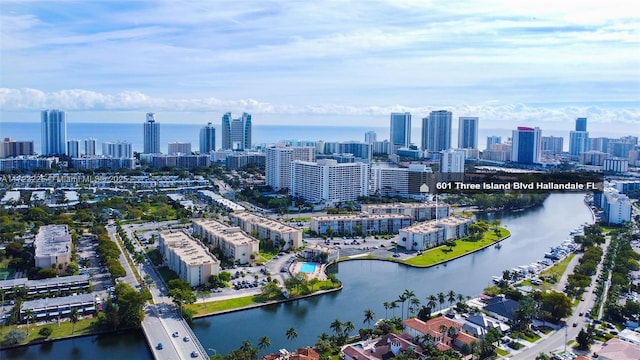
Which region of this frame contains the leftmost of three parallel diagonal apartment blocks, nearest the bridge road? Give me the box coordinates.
[158,230,220,286]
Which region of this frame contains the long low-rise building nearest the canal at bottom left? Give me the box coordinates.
[20,294,96,323]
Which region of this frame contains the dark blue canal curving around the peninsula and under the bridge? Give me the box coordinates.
[0,194,593,359]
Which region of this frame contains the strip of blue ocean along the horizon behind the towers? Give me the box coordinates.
[0,121,629,154]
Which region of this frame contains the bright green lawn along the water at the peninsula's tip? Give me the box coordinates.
[403,227,510,267]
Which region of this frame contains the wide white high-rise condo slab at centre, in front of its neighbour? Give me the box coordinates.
[289,159,369,203]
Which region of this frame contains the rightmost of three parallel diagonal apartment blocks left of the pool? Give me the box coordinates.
[229,211,302,250]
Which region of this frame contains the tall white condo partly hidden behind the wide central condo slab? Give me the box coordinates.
[265,146,316,191]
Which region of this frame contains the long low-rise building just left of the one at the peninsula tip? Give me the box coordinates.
[309,213,411,235]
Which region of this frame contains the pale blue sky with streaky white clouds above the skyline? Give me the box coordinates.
[0,0,640,133]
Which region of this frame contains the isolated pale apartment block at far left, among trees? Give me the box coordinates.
[33,225,71,269]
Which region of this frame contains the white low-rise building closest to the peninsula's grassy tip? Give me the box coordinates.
[398,216,473,251]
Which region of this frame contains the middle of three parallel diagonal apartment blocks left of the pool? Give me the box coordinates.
[193,219,260,264]
